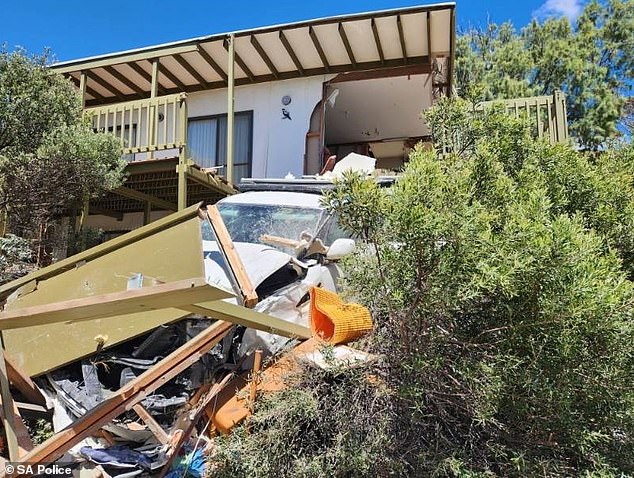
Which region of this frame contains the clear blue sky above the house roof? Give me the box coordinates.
[0,0,584,61]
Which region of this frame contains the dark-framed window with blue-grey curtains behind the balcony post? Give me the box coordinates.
[187,111,253,182]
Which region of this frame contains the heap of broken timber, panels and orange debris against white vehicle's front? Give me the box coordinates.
[0,200,372,478]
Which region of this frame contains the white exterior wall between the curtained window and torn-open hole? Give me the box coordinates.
[187,75,334,178]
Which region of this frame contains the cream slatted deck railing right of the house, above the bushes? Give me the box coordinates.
[476,90,568,143]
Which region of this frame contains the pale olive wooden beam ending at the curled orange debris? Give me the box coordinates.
[179,300,311,339]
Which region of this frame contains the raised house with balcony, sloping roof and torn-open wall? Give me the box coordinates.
[52,3,455,230]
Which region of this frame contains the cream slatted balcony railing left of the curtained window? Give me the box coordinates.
[84,93,187,155]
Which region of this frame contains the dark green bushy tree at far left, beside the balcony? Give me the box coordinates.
[0,47,124,266]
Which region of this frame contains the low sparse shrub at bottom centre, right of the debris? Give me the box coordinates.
[208,362,396,478]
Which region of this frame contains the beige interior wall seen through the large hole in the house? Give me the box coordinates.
[325,74,432,145]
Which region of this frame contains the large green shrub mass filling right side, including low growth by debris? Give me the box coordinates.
[212,99,634,477]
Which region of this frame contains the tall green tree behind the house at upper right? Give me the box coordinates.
[456,0,634,149]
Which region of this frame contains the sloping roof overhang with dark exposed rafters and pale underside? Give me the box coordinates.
[52,3,455,104]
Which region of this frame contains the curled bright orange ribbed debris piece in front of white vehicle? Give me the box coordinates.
[310,287,372,344]
